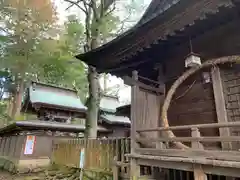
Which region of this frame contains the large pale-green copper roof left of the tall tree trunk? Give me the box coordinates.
[23,82,87,112]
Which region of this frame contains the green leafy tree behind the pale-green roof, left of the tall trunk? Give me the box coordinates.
[39,15,88,100]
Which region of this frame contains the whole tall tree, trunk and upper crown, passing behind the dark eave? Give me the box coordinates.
[62,0,146,138]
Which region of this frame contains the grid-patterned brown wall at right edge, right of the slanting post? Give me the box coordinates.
[221,65,240,149]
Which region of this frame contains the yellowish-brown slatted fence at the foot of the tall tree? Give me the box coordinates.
[52,138,130,173]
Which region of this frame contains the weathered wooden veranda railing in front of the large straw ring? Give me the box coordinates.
[136,122,240,165]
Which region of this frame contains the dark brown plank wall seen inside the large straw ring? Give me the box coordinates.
[167,73,220,149]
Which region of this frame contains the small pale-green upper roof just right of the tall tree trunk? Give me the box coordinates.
[100,95,120,113]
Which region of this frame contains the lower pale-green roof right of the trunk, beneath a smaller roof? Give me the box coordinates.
[100,114,131,125]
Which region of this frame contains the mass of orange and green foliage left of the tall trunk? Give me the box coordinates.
[0,0,87,102]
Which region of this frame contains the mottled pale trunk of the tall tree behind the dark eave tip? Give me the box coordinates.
[76,0,115,138]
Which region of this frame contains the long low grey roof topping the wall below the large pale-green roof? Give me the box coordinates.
[0,121,109,135]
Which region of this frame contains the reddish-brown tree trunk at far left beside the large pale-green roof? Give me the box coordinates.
[11,79,24,120]
